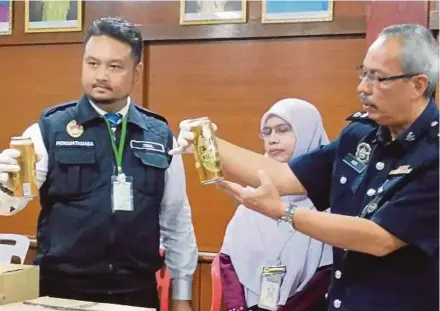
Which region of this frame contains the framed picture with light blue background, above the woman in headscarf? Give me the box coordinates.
[261,0,333,23]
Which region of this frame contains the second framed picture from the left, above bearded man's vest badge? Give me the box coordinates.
[25,0,82,33]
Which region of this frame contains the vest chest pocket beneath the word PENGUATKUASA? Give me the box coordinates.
[52,148,101,196]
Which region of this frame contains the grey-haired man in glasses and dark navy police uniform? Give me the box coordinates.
[171,25,439,311]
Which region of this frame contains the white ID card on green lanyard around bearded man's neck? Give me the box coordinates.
[104,116,133,213]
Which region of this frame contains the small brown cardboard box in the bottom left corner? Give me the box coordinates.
[0,264,40,305]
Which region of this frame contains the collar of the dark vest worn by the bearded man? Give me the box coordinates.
[76,95,148,130]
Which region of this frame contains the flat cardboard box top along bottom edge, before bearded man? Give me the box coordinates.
[0,297,155,311]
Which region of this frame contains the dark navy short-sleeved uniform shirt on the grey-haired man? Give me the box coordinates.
[289,100,439,311]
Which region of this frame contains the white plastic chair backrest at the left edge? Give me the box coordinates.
[0,233,30,264]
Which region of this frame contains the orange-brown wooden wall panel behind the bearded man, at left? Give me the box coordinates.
[0,44,143,236]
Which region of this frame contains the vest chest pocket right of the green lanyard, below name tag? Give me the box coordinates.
[133,149,169,194]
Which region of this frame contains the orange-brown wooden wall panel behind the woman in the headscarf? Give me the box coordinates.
[145,38,365,252]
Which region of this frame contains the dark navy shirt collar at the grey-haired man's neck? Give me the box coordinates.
[376,99,439,149]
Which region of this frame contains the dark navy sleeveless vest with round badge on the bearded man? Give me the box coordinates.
[36,97,173,292]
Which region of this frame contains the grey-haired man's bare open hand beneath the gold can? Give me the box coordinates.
[217,171,285,219]
